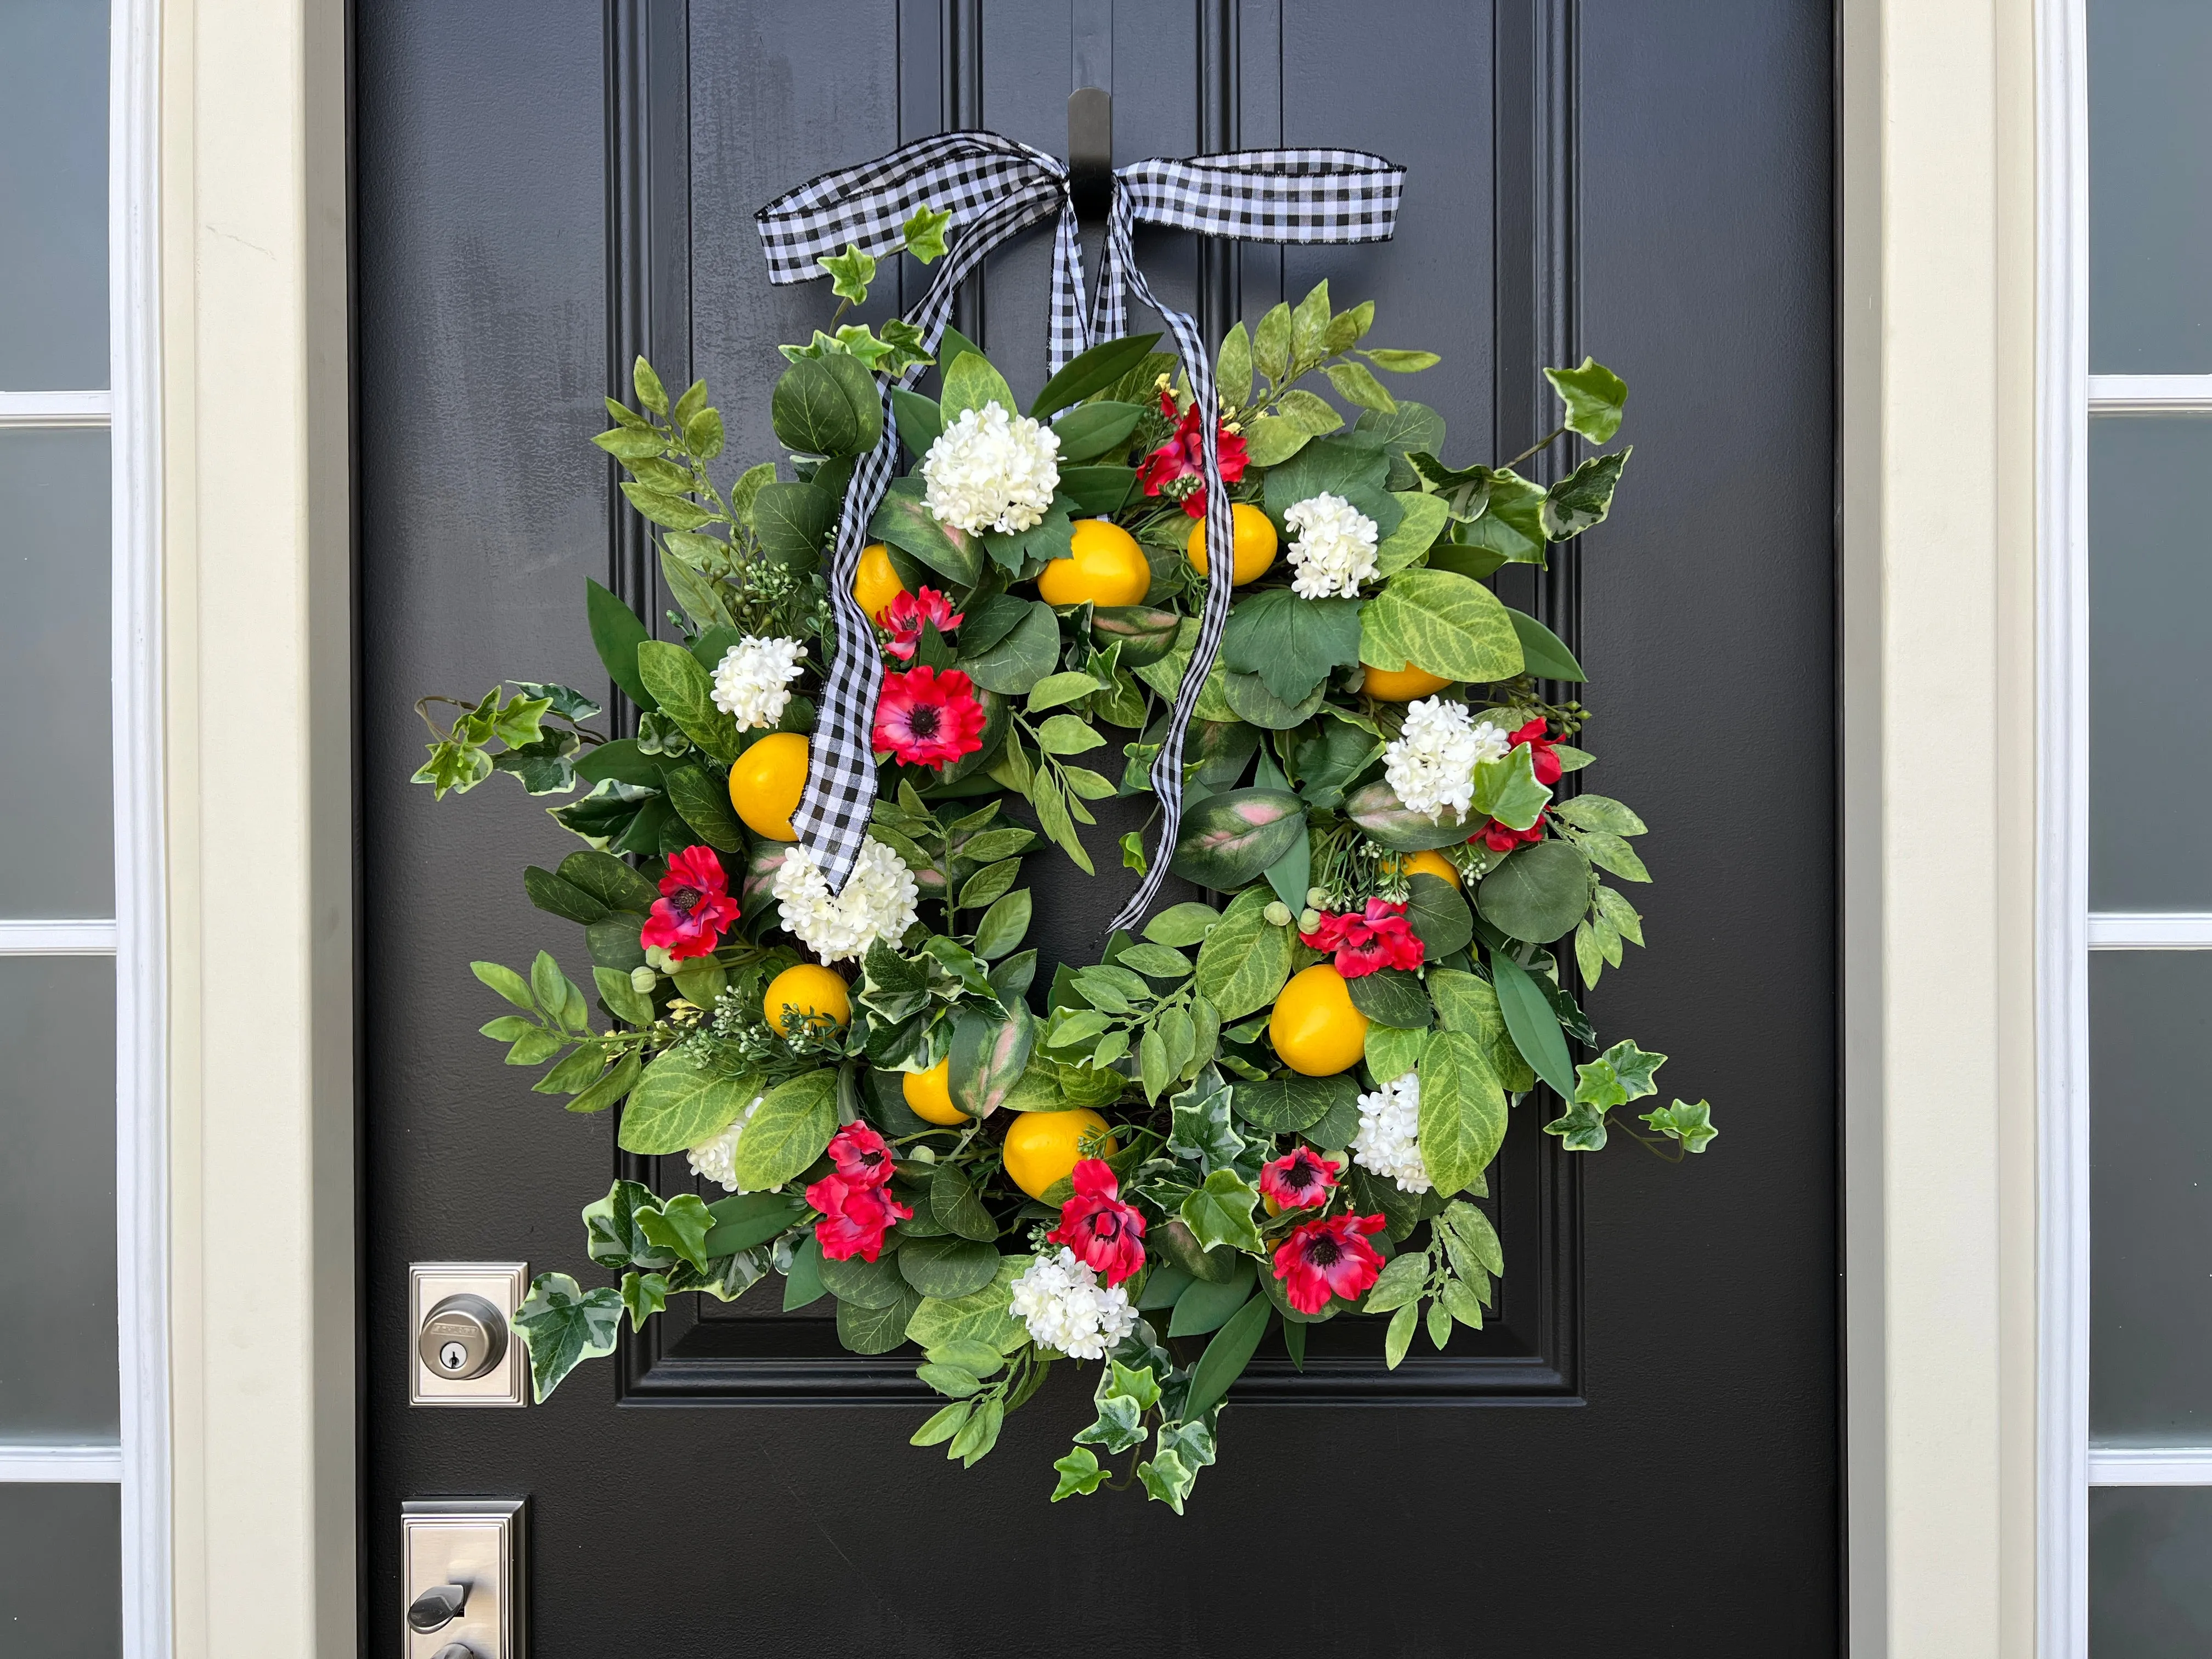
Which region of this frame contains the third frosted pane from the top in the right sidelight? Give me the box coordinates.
[2088,951,2212,1444]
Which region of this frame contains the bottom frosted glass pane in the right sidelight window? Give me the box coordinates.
[2088,1487,2212,1659]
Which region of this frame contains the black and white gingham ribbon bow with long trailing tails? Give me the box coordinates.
[754,133,1404,927]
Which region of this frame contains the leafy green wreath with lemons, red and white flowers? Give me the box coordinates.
[416,159,1714,1513]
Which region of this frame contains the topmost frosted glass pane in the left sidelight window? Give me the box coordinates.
[0,0,109,392]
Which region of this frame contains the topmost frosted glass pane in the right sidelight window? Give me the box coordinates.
[2088,0,2212,374]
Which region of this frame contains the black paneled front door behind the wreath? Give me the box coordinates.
[354,0,1843,1659]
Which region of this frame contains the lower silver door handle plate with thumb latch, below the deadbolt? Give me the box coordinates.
[400,1498,529,1659]
